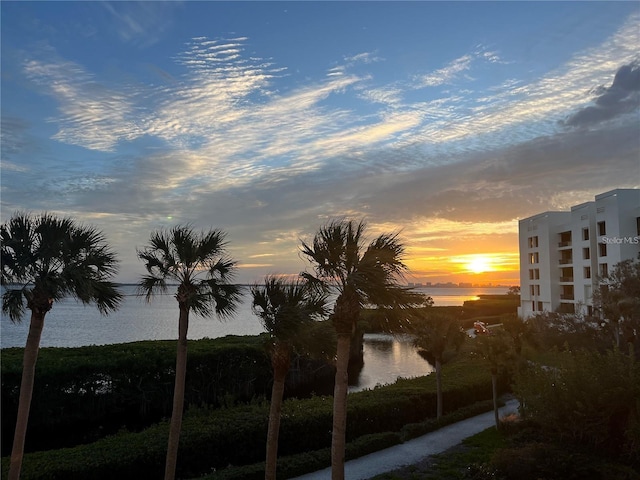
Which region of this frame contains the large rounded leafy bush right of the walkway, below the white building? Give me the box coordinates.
[514,350,640,462]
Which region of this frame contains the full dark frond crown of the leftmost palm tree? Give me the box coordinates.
[1,213,122,319]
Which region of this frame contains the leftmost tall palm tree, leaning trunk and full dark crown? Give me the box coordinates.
[0,213,122,480]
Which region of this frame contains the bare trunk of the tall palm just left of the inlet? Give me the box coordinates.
[331,334,351,480]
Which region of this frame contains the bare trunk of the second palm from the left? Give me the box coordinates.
[164,304,189,480]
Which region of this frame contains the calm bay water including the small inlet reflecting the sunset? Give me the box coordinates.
[0,285,506,391]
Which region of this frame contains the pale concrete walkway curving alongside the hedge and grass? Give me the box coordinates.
[296,399,518,480]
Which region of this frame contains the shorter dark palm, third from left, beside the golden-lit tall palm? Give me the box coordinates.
[251,275,328,480]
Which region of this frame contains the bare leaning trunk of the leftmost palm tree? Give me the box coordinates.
[8,310,46,480]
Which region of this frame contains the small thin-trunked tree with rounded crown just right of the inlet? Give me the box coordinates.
[414,313,467,419]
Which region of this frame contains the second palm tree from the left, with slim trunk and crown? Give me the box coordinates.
[138,225,240,480]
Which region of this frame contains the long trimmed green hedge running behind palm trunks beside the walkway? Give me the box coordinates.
[3,354,500,480]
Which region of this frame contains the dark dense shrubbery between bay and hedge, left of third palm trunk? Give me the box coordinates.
[1,336,271,452]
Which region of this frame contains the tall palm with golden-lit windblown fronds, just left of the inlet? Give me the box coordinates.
[302,220,424,480]
